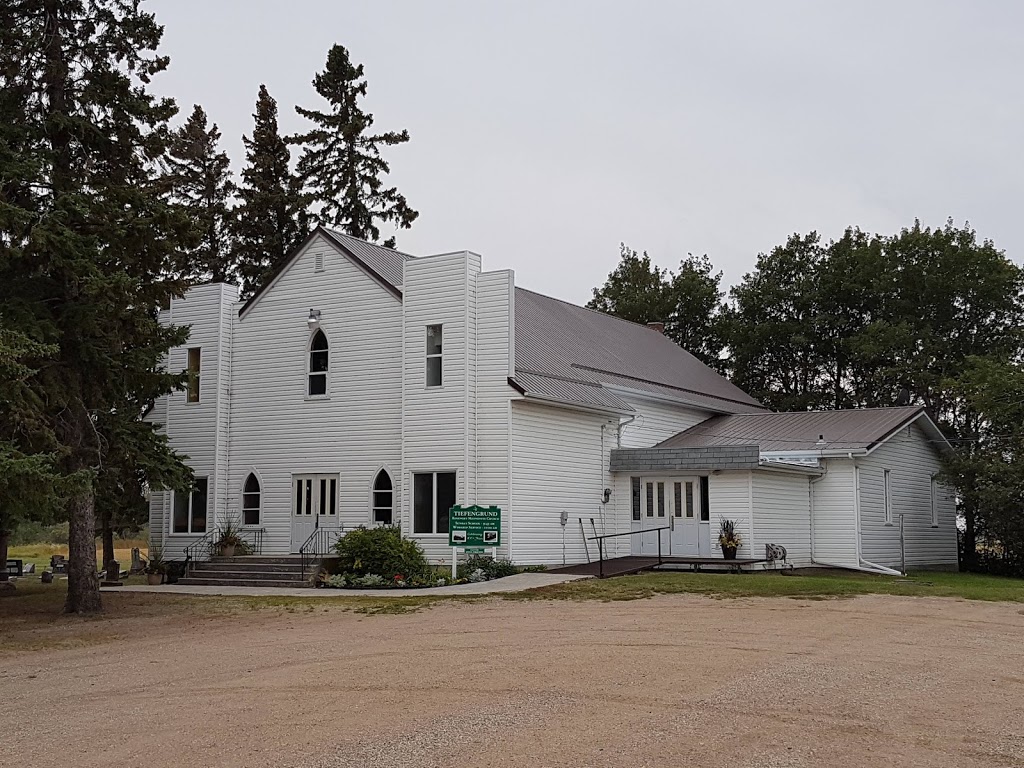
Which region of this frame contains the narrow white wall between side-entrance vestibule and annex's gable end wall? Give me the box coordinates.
[811,459,860,568]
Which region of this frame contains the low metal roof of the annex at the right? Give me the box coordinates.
[655,406,942,454]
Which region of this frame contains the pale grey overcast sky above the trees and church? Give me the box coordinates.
[147,0,1024,303]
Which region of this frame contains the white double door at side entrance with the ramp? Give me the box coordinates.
[639,477,702,557]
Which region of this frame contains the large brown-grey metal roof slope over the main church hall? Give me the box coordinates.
[515,288,764,413]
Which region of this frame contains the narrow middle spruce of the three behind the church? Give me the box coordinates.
[231,85,308,298]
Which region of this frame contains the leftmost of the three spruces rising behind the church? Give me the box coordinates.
[162,104,236,283]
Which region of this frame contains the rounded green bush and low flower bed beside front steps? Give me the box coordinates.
[318,525,543,589]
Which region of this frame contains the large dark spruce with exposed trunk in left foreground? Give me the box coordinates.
[0,0,188,612]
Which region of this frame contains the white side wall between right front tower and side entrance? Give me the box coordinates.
[511,400,614,564]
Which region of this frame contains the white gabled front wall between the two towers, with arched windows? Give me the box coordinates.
[228,237,403,553]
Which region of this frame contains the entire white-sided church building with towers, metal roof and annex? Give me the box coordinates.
[147,227,956,569]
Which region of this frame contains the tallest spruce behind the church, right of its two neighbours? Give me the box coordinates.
[290,45,420,247]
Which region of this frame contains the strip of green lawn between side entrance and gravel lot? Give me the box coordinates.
[500,569,1024,602]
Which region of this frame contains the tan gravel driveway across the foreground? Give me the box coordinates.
[0,595,1024,768]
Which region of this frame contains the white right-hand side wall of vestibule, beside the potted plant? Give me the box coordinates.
[752,470,811,567]
